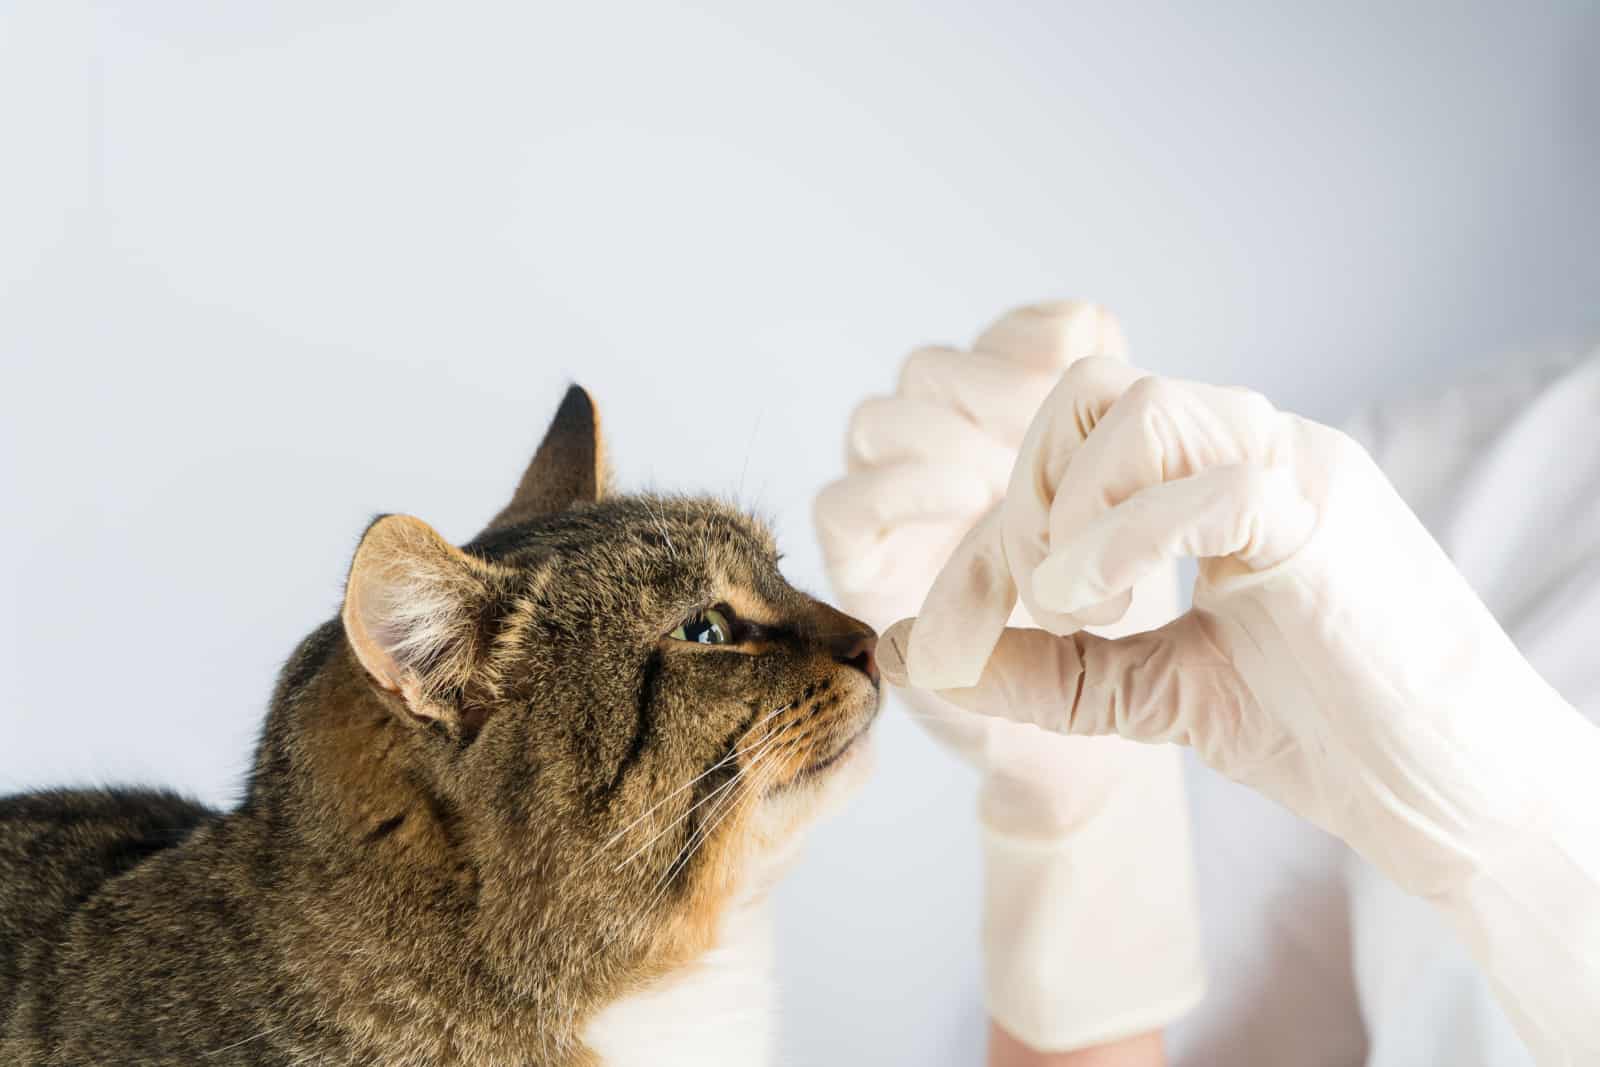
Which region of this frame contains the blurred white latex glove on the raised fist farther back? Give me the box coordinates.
[816,302,1205,1049]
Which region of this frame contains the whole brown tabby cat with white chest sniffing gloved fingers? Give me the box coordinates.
[0,387,878,1067]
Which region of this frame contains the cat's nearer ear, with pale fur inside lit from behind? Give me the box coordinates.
[342,515,494,718]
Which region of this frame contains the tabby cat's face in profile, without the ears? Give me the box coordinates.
[472,498,878,907]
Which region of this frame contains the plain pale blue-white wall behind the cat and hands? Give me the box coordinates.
[0,0,1600,1064]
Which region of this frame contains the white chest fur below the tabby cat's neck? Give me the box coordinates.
[584,904,774,1067]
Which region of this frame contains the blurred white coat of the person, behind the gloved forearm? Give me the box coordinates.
[1349,350,1600,1067]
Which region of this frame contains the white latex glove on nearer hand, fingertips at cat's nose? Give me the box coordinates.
[880,360,1600,1065]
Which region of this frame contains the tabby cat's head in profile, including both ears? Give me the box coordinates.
[332,387,878,979]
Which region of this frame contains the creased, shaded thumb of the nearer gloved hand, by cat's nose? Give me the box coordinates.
[878,613,1228,744]
